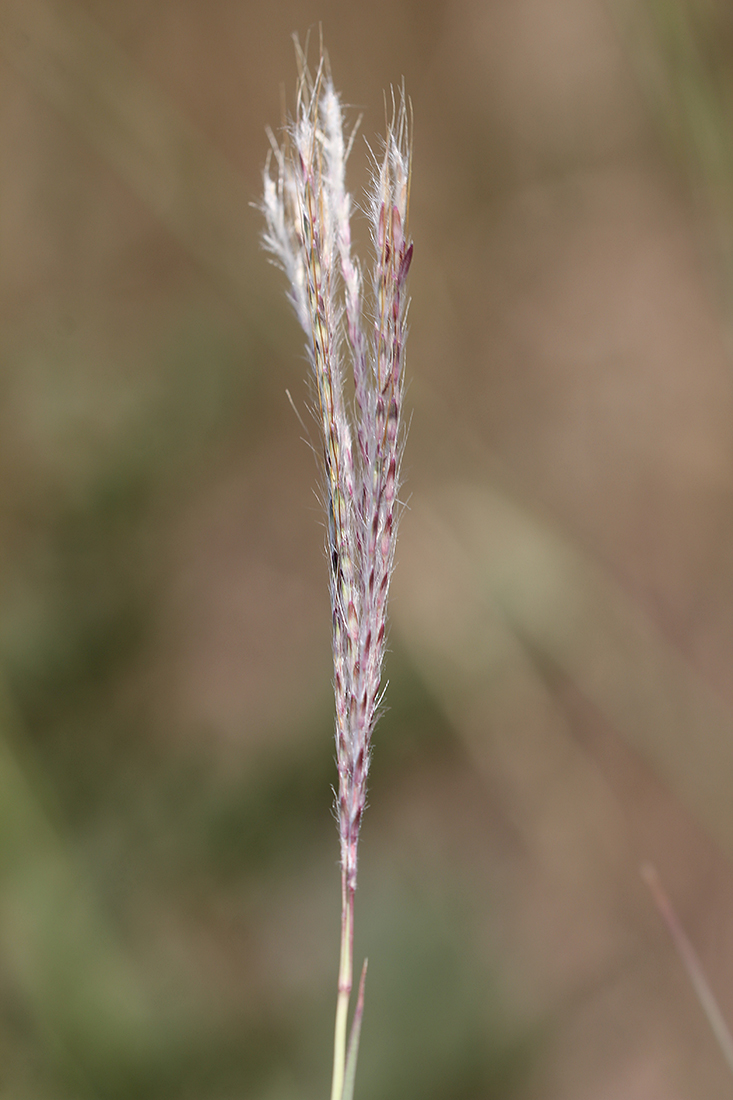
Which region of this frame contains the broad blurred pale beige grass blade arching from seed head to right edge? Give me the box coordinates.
[394,485,733,855]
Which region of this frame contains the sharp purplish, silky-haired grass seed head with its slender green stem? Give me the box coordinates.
[262,40,413,1100]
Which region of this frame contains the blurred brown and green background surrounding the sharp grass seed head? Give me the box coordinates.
[0,0,733,1100]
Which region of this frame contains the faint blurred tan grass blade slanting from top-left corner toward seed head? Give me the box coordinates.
[0,0,256,315]
